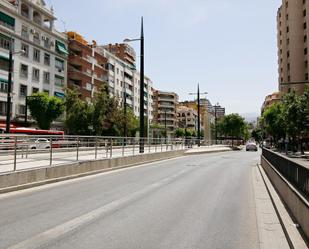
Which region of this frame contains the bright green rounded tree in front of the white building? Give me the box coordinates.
[27,93,64,130]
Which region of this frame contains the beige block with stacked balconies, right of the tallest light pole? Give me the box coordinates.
[153,90,179,137]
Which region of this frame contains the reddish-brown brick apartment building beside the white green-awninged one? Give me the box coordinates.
[67,32,108,102]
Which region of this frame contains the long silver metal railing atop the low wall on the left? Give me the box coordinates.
[0,134,223,173]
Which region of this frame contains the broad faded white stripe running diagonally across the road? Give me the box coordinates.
[7,168,192,249]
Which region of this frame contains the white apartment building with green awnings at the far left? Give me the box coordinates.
[0,0,68,123]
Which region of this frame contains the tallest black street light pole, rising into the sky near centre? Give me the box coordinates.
[124,17,145,153]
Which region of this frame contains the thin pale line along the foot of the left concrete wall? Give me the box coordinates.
[0,156,186,200]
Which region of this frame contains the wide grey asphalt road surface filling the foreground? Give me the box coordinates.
[0,152,259,249]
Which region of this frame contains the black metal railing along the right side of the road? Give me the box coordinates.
[262,148,309,200]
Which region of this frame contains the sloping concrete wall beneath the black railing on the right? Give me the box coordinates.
[261,156,309,238]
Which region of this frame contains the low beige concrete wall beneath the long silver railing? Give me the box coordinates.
[0,150,185,193]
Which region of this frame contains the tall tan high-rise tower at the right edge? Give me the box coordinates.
[277,0,309,94]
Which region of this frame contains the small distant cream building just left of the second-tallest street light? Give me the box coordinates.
[177,106,198,131]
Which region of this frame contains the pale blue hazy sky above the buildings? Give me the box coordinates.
[46,0,281,116]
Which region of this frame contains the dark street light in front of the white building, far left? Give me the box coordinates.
[6,38,25,133]
